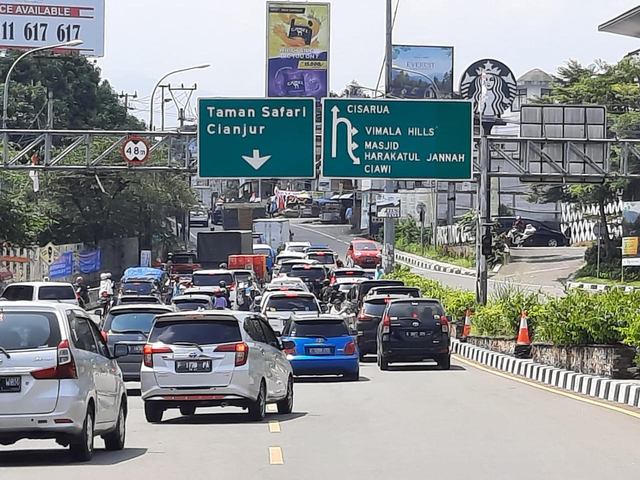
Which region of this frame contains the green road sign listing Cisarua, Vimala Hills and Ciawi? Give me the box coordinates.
[322,98,473,180]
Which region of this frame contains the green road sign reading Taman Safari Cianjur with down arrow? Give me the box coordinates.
[198,98,316,178]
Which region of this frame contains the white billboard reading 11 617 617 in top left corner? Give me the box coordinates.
[0,0,105,57]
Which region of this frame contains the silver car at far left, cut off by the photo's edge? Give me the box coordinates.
[0,302,128,461]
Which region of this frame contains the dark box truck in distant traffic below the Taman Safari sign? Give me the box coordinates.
[198,230,253,269]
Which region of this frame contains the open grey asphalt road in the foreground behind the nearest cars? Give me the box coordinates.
[0,361,640,480]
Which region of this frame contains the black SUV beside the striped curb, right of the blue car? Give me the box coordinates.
[377,298,451,370]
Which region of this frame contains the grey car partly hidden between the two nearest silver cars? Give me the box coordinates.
[102,304,176,382]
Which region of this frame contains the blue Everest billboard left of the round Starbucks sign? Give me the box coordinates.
[391,45,453,98]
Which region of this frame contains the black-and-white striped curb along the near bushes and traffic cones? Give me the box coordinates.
[451,340,640,408]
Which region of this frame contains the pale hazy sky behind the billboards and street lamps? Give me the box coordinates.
[98,0,640,125]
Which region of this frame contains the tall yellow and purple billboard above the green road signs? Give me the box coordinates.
[267,2,329,101]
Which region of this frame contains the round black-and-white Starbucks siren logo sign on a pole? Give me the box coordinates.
[460,59,518,117]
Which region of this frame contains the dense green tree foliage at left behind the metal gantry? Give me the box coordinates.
[0,52,195,247]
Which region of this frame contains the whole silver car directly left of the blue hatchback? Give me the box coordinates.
[140,310,294,423]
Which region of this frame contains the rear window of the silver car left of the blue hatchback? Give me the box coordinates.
[149,320,242,345]
